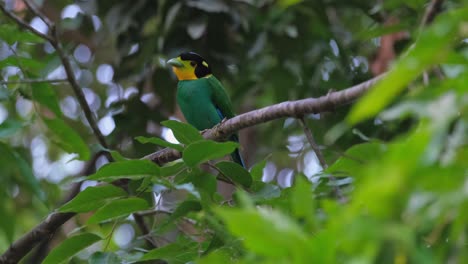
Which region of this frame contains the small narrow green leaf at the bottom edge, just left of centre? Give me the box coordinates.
[140,241,198,263]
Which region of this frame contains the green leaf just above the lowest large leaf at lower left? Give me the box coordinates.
[88,197,150,224]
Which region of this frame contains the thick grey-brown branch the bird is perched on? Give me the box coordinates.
[143,74,384,165]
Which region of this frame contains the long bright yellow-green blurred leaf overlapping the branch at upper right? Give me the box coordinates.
[347,8,467,124]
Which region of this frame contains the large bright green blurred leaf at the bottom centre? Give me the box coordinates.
[217,208,309,263]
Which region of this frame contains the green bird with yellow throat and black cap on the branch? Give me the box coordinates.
[167,52,246,168]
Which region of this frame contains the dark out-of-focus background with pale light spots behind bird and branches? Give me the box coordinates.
[0,0,467,263]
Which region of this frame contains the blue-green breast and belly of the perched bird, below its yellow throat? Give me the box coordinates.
[177,78,222,130]
